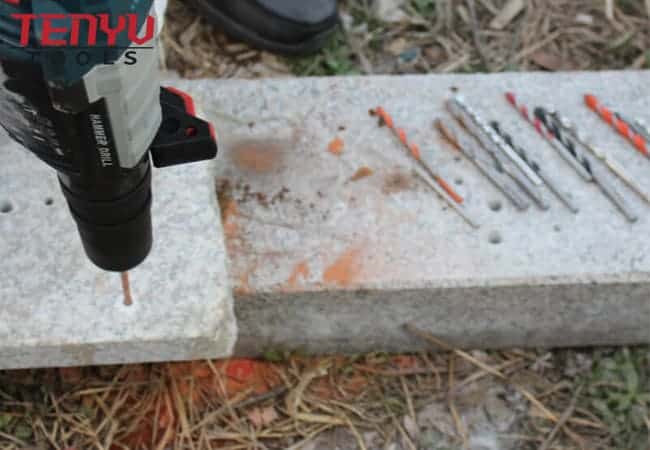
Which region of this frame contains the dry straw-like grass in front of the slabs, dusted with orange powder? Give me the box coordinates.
[0,340,650,450]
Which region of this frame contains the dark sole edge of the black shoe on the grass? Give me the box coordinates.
[192,0,338,56]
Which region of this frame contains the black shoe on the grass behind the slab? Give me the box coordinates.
[196,0,339,55]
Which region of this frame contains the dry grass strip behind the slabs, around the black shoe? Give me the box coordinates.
[164,0,650,78]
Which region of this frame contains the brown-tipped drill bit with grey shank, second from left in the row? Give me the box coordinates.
[434,119,530,211]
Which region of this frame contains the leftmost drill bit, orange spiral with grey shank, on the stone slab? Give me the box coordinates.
[371,106,480,228]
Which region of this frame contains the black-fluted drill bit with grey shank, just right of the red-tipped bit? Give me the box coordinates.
[535,107,638,222]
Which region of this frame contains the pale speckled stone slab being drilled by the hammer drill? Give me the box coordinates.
[0,135,236,369]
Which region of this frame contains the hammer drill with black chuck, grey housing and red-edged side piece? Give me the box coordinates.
[0,0,217,272]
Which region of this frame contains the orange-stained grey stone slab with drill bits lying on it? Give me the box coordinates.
[173,71,650,354]
